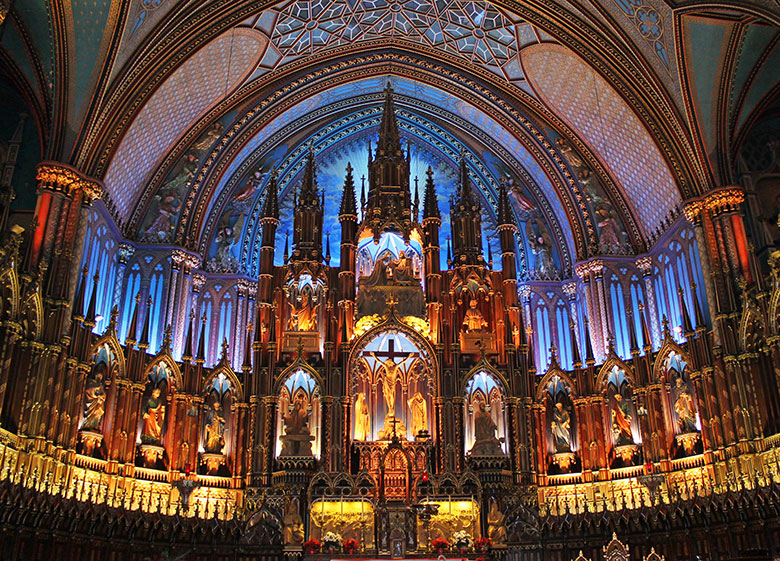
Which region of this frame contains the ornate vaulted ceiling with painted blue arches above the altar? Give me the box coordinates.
[0,0,780,269]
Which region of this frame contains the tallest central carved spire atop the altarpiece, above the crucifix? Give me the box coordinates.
[361,83,412,241]
